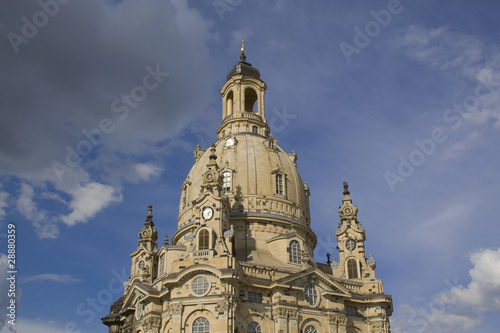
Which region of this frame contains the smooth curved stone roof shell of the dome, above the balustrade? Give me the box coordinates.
[179,133,309,223]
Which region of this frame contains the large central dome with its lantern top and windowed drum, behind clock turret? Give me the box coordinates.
[176,41,316,270]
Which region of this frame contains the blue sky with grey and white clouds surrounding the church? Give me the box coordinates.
[0,0,500,333]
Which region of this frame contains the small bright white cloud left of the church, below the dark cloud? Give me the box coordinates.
[60,183,122,226]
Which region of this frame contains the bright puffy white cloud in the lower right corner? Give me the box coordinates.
[392,248,500,333]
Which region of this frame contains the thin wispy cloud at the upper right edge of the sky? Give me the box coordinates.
[393,25,500,159]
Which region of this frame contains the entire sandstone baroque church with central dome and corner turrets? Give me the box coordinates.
[102,43,392,333]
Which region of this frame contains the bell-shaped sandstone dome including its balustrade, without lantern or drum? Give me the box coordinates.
[179,133,310,227]
